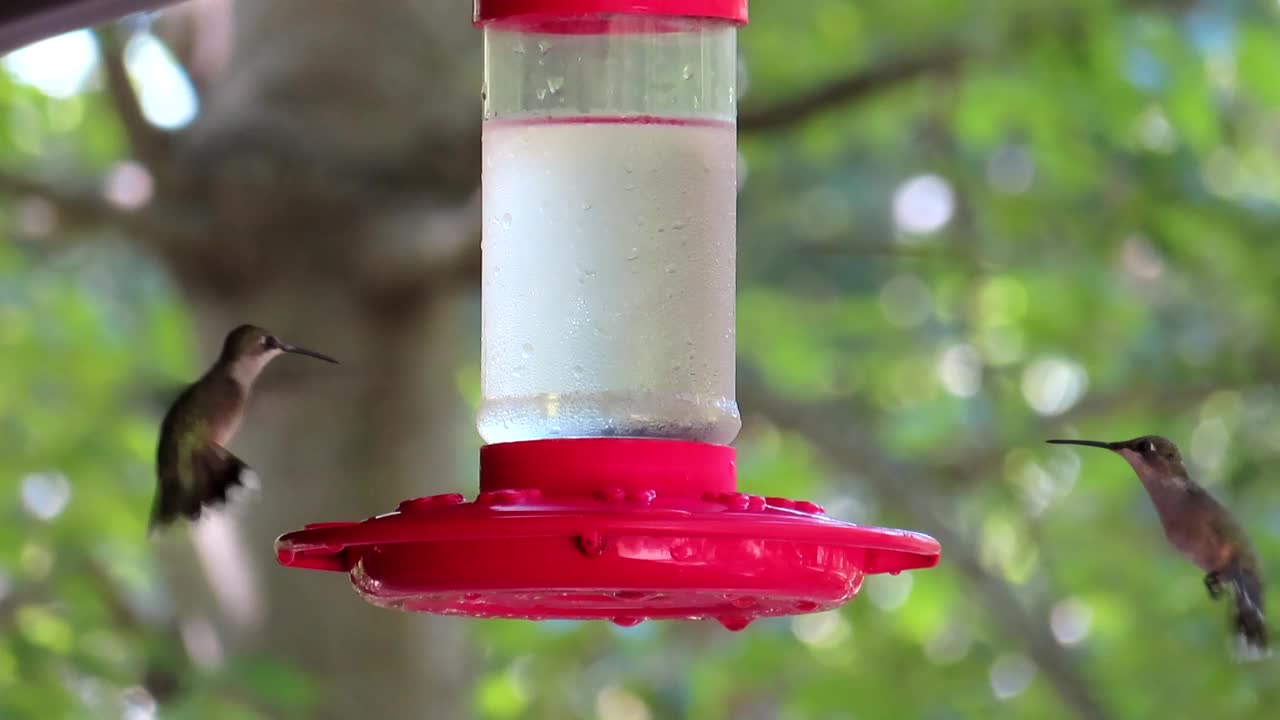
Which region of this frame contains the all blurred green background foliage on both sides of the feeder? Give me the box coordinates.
[0,0,1280,720]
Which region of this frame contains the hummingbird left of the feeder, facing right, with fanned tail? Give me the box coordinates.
[150,325,338,530]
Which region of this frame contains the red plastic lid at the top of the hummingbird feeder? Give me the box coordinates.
[472,0,746,24]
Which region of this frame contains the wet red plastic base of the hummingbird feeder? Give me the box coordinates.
[275,438,941,630]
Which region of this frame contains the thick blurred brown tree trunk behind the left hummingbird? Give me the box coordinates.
[148,0,480,720]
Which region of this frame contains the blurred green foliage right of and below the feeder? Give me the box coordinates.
[477,0,1280,719]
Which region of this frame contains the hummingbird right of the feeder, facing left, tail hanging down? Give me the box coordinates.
[1047,436,1267,653]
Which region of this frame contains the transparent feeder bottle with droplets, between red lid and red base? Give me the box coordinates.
[476,14,741,443]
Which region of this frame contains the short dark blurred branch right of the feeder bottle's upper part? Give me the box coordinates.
[737,47,969,133]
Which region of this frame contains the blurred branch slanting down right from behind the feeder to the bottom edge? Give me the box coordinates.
[737,370,1111,720]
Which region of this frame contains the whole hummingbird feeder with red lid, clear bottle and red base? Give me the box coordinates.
[275,0,940,629]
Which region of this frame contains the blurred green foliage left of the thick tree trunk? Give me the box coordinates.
[0,50,315,720]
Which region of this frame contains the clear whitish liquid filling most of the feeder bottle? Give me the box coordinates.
[477,122,740,442]
